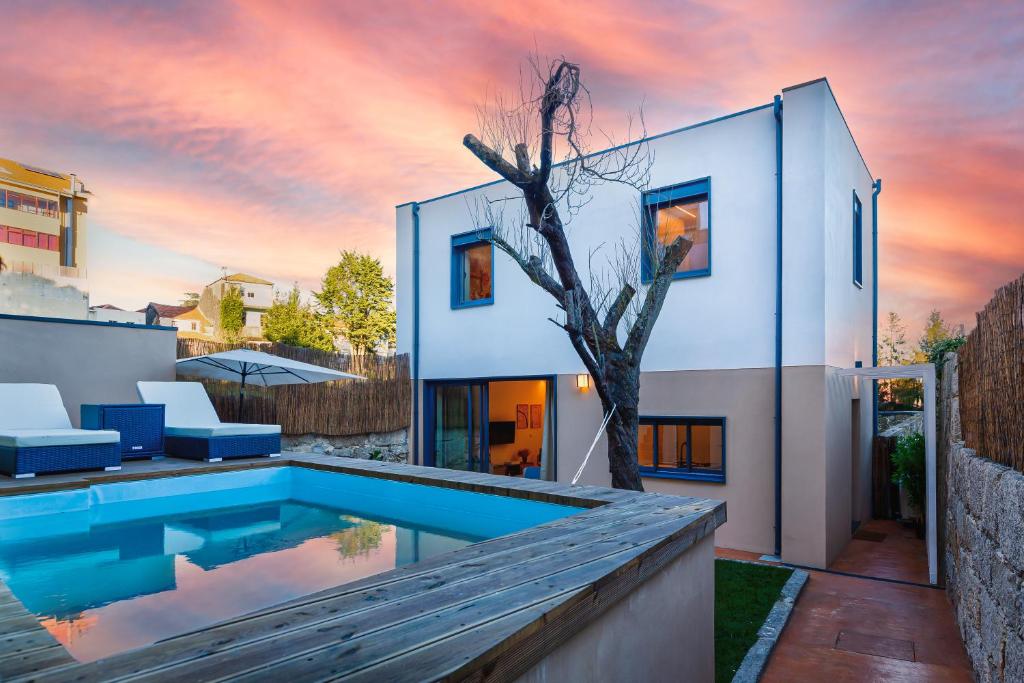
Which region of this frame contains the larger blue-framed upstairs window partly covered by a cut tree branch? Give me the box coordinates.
[640,178,711,283]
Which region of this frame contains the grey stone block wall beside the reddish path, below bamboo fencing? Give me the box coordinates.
[939,357,1024,682]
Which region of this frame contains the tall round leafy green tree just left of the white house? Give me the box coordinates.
[314,251,395,353]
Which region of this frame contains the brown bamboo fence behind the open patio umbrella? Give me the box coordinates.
[178,338,412,436]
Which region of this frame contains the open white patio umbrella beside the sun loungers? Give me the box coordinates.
[177,348,366,420]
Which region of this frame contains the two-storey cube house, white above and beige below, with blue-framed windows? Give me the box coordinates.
[396,79,881,567]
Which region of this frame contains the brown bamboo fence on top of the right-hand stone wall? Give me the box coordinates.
[956,275,1024,472]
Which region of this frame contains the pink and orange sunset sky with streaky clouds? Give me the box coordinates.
[0,0,1024,336]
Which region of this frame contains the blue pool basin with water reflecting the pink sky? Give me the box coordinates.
[0,467,580,661]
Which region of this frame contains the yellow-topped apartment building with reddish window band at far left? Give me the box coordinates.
[0,159,90,318]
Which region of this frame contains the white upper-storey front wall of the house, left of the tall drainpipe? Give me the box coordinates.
[397,108,775,379]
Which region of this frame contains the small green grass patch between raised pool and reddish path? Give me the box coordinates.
[715,560,793,681]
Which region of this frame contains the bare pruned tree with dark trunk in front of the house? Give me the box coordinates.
[463,57,691,490]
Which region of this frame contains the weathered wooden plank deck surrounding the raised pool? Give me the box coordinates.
[0,454,725,683]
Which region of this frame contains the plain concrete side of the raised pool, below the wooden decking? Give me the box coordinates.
[518,538,715,683]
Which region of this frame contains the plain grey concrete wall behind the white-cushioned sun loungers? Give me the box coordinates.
[0,316,176,427]
